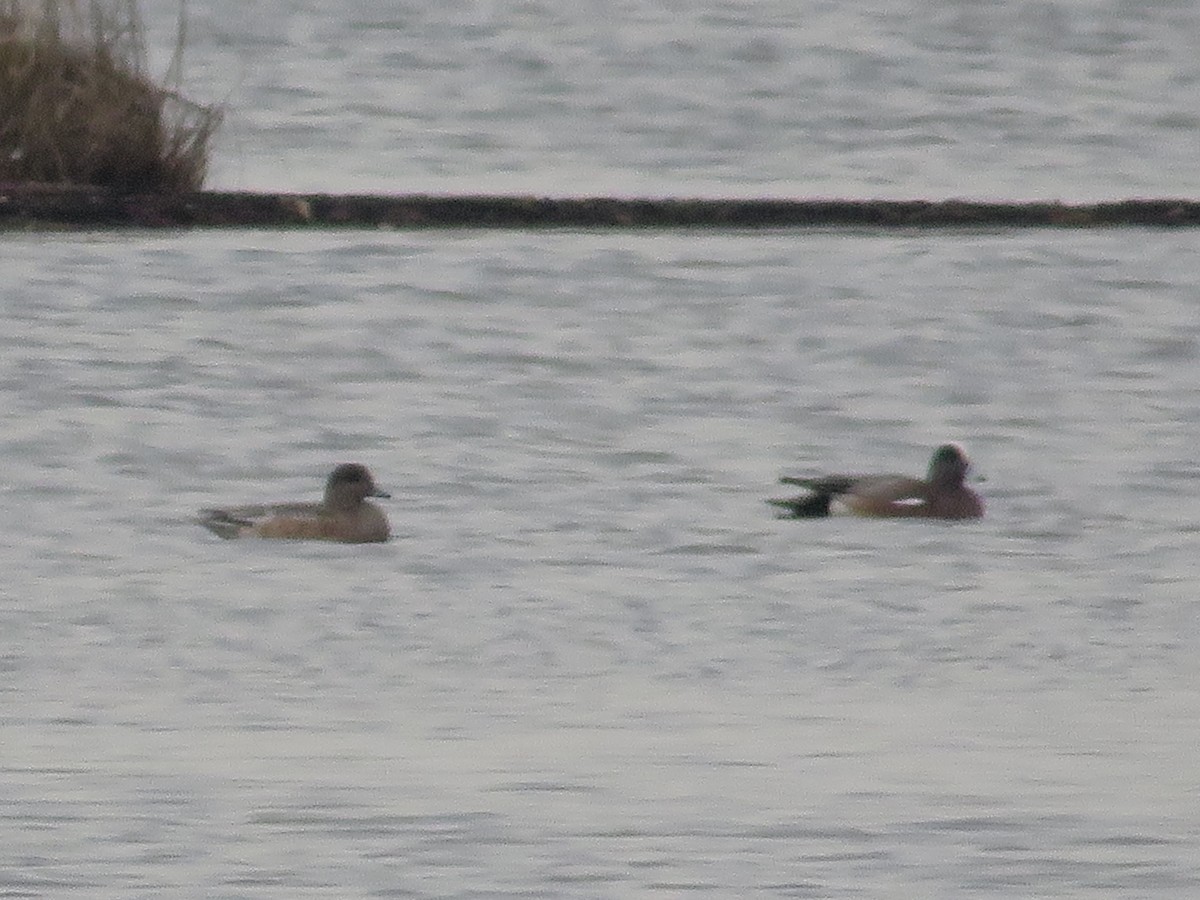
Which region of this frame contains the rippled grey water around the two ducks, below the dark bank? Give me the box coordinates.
[7,232,1200,898]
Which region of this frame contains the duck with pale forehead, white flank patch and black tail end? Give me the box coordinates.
[768,444,983,518]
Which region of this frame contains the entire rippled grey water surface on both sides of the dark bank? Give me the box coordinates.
[7,0,1200,899]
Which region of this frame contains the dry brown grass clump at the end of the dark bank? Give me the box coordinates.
[0,0,221,193]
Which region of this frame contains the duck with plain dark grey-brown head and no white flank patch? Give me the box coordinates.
[199,463,391,544]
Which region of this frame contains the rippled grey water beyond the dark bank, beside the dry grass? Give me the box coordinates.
[142,0,1200,200]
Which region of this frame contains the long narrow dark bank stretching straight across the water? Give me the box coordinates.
[0,185,1200,229]
